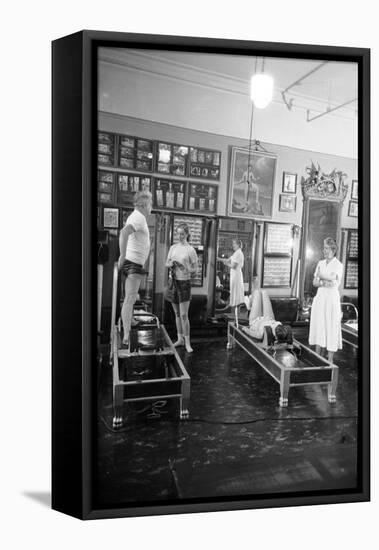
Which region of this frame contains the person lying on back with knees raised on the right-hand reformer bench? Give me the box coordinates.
[242,289,292,345]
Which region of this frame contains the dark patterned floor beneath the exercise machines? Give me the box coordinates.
[95,327,358,506]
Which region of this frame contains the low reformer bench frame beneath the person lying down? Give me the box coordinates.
[227,322,338,407]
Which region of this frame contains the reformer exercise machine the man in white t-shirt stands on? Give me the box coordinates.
[110,263,191,428]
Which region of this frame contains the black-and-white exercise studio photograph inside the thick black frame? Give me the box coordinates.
[87,35,362,508]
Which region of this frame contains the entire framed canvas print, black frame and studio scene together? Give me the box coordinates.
[52,31,370,519]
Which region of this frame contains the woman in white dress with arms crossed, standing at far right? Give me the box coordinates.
[309,237,343,363]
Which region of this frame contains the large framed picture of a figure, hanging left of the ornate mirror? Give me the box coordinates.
[228,147,277,218]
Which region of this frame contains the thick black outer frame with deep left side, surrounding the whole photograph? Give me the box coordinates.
[52,31,370,520]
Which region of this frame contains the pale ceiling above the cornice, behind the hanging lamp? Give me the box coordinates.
[100,48,358,118]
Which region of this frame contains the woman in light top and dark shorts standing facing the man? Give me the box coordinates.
[166,223,198,353]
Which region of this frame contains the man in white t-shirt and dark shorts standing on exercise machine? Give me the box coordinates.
[118,191,152,346]
